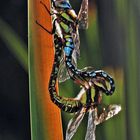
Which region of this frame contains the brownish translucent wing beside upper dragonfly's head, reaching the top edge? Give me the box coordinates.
[78,0,88,29]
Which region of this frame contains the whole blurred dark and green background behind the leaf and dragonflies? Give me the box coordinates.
[0,0,140,140]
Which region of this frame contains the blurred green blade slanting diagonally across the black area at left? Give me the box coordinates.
[0,19,28,71]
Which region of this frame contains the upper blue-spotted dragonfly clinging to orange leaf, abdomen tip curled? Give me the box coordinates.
[36,0,115,95]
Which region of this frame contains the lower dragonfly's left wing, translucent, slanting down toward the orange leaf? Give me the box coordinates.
[66,108,85,140]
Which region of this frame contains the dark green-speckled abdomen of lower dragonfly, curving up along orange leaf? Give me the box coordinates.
[49,34,83,113]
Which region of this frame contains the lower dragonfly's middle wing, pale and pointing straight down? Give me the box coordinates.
[85,109,97,140]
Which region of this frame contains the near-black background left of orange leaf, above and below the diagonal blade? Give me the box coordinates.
[0,0,30,140]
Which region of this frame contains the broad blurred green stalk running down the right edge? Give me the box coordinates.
[117,0,140,139]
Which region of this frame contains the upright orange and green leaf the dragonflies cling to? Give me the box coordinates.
[28,0,63,140]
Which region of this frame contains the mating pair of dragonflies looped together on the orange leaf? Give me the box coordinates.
[36,0,119,140]
